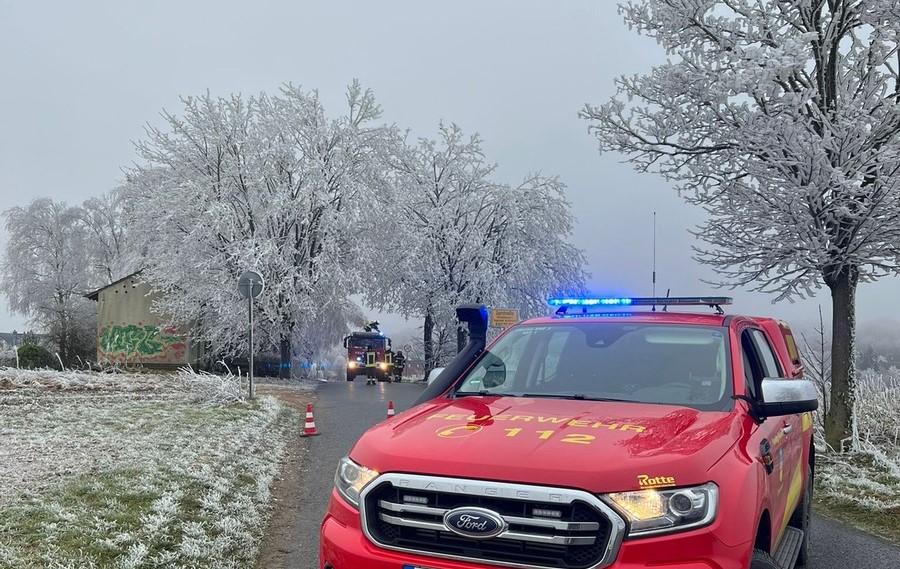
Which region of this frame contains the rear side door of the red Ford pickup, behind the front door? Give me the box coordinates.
[750,329,803,535]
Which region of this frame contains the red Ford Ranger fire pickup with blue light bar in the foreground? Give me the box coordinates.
[319,297,818,569]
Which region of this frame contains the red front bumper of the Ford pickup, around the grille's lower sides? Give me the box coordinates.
[319,493,753,569]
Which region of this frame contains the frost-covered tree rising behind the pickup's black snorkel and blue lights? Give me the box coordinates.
[367,124,584,369]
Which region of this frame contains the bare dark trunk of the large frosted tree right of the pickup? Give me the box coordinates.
[825,267,858,451]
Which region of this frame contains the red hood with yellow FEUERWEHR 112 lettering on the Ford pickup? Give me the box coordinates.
[350,396,742,492]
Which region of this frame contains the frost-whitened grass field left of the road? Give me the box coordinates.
[0,369,298,569]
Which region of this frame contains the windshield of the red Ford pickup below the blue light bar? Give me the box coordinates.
[456,322,732,410]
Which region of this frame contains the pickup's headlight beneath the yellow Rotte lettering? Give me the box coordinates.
[606,482,719,537]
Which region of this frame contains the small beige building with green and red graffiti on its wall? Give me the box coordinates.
[86,271,202,368]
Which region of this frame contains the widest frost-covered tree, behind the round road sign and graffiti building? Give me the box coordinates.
[125,83,398,374]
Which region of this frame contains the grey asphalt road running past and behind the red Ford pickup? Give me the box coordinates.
[298,379,900,569]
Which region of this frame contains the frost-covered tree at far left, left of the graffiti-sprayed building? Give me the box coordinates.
[0,198,98,365]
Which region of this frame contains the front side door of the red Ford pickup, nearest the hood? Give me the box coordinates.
[740,327,788,538]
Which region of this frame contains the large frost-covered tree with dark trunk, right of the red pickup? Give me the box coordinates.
[582,0,900,448]
